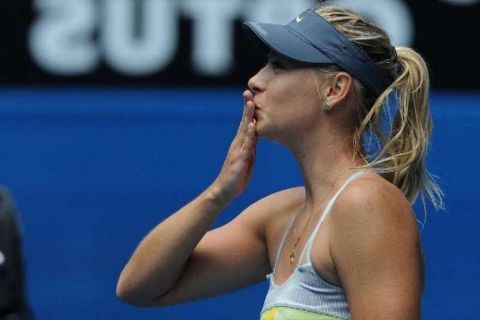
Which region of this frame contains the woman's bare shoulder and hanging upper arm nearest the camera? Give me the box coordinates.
[330,181,423,319]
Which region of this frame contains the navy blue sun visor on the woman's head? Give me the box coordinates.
[243,9,392,96]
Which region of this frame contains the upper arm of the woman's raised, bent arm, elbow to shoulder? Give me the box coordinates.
[154,189,304,306]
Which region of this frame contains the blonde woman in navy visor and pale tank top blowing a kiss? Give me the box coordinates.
[117,7,441,320]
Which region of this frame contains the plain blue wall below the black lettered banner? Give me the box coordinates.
[0,88,480,320]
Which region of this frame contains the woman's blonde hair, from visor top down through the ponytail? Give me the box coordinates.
[316,6,443,209]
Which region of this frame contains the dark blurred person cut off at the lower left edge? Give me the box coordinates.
[0,188,32,320]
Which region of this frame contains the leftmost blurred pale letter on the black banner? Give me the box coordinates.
[28,0,99,76]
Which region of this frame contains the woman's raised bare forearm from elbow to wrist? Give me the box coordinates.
[117,188,227,305]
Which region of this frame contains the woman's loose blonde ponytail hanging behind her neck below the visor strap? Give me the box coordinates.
[354,47,443,209]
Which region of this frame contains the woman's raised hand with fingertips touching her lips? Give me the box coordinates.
[210,90,257,203]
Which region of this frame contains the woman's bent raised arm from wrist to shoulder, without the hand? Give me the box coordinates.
[117,188,304,307]
